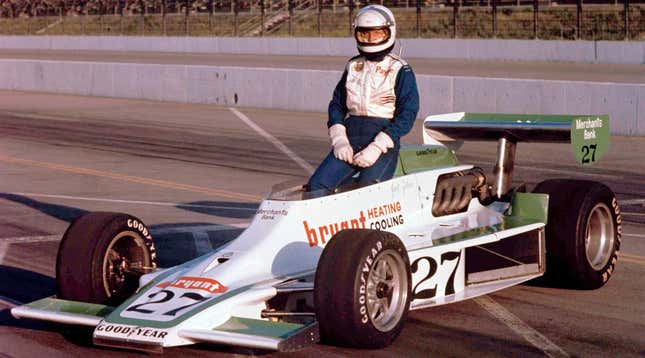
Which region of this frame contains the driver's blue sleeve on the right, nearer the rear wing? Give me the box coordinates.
[383,65,419,142]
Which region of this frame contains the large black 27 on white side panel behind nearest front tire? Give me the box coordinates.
[410,251,464,300]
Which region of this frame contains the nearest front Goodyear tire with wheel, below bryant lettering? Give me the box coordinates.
[314,230,412,348]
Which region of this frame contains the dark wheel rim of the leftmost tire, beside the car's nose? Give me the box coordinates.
[103,231,152,298]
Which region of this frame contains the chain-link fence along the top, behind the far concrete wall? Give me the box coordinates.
[0,0,645,40]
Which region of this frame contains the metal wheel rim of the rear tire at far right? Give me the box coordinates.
[585,203,615,270]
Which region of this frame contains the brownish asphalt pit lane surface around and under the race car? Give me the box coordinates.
[0,92,645,357]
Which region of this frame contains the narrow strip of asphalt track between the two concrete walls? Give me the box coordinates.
[0,49,645,84]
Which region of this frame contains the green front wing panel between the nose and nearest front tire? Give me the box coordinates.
[213,317,306,338]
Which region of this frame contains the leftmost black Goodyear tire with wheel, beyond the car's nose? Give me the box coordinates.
[56,212,157,304]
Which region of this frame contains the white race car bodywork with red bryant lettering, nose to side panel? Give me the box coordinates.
[83,160,544,346]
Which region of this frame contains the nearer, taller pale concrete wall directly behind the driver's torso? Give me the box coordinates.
[0,59,645,135]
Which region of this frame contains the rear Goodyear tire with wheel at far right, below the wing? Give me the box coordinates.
[533,179,622,289]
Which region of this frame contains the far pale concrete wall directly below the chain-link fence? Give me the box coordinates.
[0,36,645,64]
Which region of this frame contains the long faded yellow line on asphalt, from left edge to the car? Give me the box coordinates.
[0,155,262,201]
